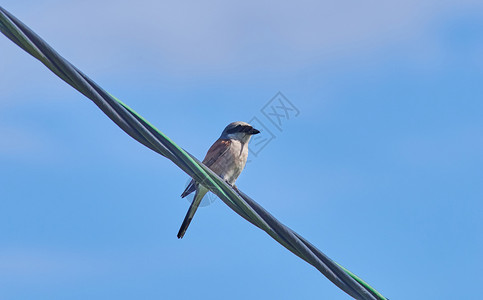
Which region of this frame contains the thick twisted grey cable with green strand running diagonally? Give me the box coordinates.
[0,7,386,300]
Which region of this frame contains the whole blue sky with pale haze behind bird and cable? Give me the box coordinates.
[0,0,483,299]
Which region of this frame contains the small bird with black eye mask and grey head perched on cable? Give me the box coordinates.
[178,122,260,239]
